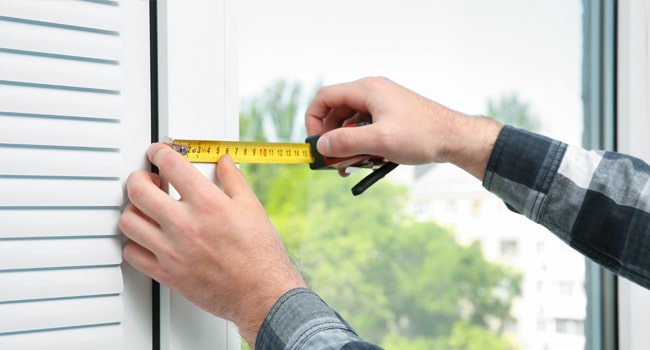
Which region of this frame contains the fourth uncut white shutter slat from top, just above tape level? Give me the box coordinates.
[0,115,122,149]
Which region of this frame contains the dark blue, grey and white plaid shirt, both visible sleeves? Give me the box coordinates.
[256,126,650,350]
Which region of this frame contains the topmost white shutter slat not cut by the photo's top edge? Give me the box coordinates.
[0,17,121,60]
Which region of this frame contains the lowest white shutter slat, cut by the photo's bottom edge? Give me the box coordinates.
[0,322,124,350]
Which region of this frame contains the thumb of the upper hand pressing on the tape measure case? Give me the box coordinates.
[316,124,383,157]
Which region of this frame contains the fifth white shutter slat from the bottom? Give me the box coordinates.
[0,208,120,239]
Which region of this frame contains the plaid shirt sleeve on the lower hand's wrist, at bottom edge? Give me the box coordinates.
[255,288,380,350]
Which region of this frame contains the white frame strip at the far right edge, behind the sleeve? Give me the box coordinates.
[617,0,650,350]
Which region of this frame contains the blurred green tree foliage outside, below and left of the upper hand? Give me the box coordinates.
[241,83,521,350]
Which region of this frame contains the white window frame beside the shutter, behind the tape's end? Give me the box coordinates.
[154,0,240,350]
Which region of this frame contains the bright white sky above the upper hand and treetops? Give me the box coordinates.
[237,0,582,143]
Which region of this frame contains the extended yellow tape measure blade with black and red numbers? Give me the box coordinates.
[170,139,314,164]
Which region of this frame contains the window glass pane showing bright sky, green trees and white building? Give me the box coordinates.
[238,0,587,349]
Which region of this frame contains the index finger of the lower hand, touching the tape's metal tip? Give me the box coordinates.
[147,143,214,199]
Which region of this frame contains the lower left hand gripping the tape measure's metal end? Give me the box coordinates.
[119,144,306,346]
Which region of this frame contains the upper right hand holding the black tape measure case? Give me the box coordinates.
[305,78,501,179]
